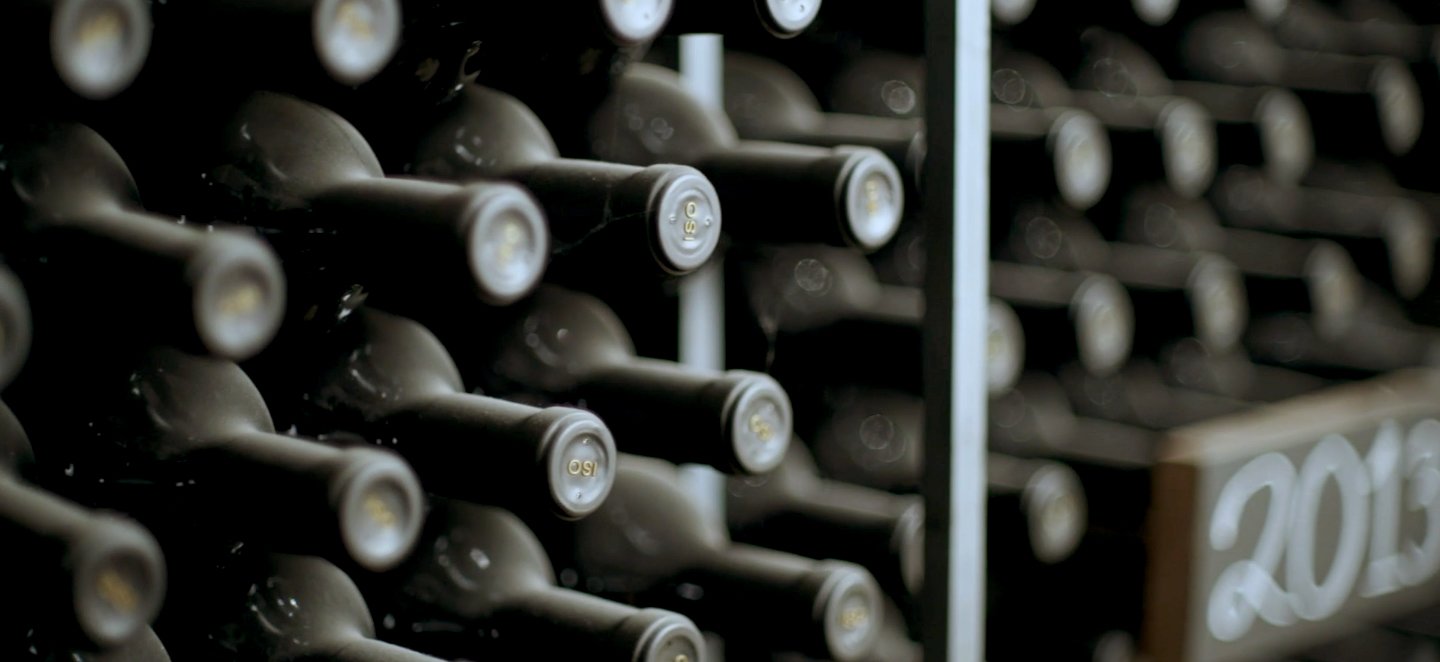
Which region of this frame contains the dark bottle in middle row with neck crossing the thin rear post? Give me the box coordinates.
[432,285,793,473]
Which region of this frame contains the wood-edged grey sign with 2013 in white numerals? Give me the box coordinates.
[1145,370,1440,662]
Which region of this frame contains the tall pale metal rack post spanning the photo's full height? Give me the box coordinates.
[922,0,989,662]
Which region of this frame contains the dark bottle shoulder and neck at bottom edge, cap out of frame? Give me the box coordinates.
[160,553,439,662]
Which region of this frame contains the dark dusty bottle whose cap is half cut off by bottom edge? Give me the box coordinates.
[367,501,704,662]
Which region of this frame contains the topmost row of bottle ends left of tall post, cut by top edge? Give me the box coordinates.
[3,0,821,99]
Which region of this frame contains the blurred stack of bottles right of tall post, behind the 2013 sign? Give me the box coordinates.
[961,0,1440,661]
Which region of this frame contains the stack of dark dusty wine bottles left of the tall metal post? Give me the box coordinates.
[0,0,956,662]
